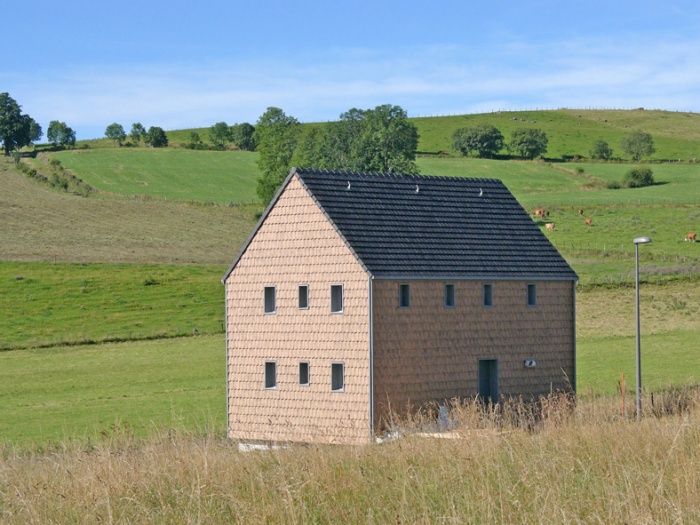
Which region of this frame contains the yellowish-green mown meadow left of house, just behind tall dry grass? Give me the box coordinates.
[0,335,226,444]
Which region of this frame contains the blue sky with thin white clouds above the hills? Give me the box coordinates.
[5,0,700,139]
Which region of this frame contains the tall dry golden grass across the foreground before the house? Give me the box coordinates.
[0,390,700,524]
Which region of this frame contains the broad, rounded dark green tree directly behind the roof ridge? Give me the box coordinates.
[295,104,418,173]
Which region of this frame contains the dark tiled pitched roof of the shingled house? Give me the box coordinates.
[296,169,577,279]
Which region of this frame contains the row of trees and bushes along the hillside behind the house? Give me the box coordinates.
[0,93,655,204]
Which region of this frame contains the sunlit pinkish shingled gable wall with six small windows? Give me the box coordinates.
[226,176,371,443]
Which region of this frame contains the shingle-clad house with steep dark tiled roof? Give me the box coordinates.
[222,169,578,443]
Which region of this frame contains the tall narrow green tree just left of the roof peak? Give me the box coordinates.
[254,107,301,206]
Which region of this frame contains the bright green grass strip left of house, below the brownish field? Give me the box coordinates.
[0,262,226,350]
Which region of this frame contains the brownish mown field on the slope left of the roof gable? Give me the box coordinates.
[0,157,260,264]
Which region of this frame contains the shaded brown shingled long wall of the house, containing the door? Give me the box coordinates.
[373,281,575,428]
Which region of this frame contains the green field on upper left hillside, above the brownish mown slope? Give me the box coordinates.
[47,148,259,204]
